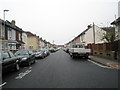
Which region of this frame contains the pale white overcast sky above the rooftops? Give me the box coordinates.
[0,0,120,44]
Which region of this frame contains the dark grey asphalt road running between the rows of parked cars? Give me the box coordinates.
[3,50,118,88]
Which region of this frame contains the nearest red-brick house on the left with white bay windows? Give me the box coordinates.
[5,20,24,52]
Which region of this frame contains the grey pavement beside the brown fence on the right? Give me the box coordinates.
[89,55,120,69]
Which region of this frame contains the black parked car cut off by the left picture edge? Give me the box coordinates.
[0,51,20,72]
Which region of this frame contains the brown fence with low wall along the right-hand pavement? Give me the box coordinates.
[86,40,120,59]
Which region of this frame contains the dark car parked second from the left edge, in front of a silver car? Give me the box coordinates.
[15,50,35,66]
